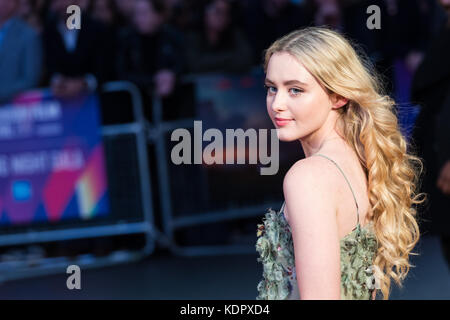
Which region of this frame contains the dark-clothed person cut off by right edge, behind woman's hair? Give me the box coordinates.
[411,0,450,267]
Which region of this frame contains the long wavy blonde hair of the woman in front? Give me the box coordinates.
[264,27,425,300]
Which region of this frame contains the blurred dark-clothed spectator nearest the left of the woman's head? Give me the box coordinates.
[186,0,252,73]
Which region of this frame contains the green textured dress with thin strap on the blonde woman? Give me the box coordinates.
[256,154,378,300]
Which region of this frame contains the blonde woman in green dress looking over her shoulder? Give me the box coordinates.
[256,27,424,299]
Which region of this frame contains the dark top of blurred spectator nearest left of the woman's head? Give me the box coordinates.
[186,28,252,73]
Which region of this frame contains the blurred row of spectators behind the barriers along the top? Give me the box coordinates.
[0,0,444,102]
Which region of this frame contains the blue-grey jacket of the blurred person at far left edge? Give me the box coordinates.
[0,18,42,103]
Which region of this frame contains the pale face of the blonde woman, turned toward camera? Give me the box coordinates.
[265,52,342,141]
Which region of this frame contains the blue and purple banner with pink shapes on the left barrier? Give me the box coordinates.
[0,90,109,226]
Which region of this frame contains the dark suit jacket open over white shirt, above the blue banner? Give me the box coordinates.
[43,15,112,85]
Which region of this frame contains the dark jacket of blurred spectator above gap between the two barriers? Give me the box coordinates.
[116,24,193,121]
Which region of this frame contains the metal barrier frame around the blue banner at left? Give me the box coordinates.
[0,81,167,281]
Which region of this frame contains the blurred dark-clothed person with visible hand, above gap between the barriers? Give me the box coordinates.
[117,0,185,118]
